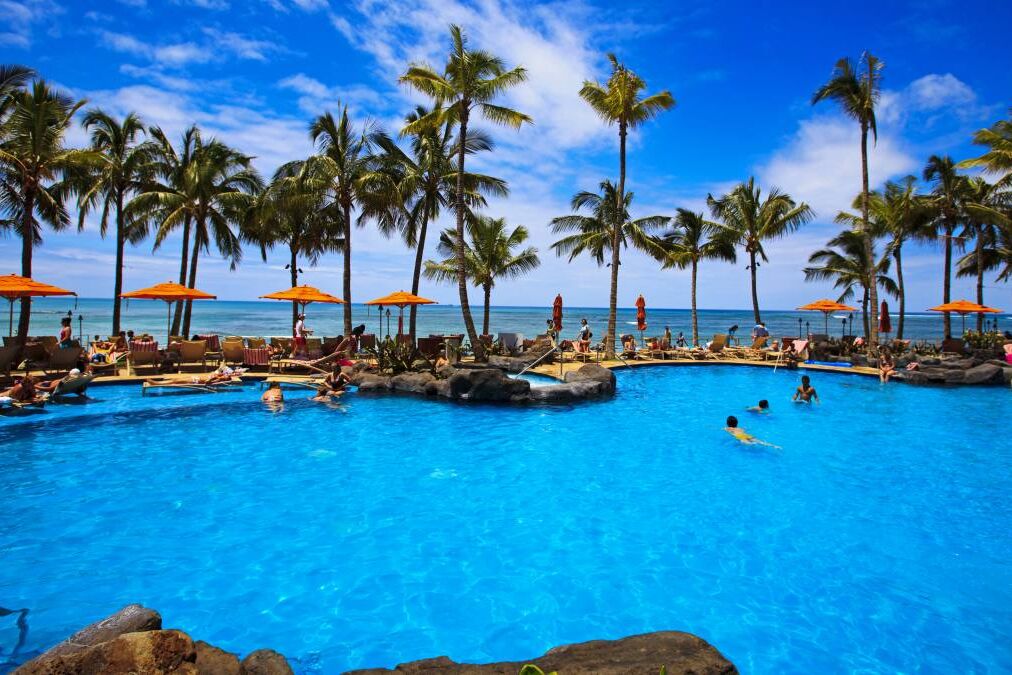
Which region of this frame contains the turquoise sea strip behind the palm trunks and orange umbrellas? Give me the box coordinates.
[15,298,1012,340]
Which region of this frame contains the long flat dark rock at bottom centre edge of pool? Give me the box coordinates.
[345,630,738,675]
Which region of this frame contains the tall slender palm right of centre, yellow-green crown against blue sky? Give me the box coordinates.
[580,54,675,358]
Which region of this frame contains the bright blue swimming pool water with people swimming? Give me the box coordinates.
[0,367,1012,673]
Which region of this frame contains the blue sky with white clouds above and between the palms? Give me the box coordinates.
[0,0,1012,310]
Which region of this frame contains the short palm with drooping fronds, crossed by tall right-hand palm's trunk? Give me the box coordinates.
[805,230,900,339]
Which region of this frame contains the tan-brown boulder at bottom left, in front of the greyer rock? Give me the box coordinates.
[14,630,196,675]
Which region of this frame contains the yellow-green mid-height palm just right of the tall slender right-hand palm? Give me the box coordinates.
[836,176,930,340]
